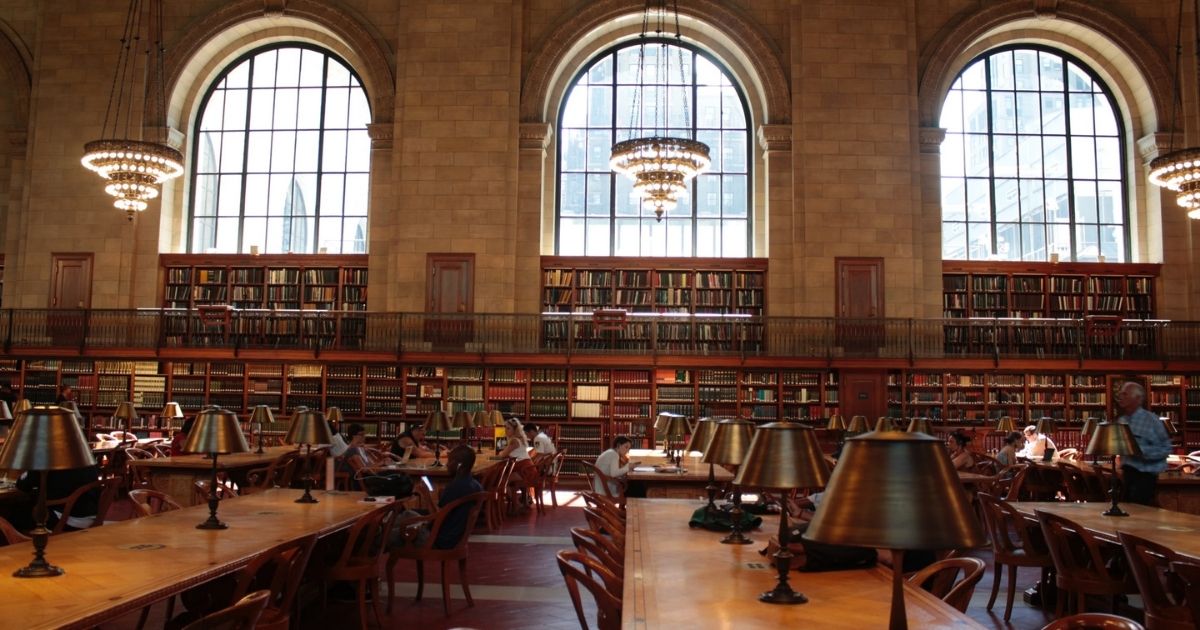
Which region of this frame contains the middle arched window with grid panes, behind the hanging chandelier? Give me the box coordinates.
[556,42,751,257]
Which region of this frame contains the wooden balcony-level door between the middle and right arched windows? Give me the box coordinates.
[834,258,883,354]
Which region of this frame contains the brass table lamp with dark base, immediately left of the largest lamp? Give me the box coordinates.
[733,422,829,604]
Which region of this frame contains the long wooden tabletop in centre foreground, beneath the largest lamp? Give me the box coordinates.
[622,499,983,630]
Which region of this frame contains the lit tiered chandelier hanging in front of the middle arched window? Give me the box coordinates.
[608,0,712,221]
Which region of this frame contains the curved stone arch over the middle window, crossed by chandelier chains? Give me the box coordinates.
[520,0,791,124]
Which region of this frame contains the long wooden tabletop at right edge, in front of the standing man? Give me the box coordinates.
[1010,502,1200,559]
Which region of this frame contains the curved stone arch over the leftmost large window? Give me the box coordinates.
[159,0,396,126]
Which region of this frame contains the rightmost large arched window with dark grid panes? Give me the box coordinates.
[941,44,1129,262]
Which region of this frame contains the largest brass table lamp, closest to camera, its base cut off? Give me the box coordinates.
[804,431,985,630]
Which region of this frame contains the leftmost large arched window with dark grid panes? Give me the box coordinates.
[188,43,371,253]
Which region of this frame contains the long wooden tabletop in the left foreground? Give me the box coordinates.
[0,488,385,629]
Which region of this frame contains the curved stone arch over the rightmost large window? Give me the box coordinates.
[918,0,1174,133]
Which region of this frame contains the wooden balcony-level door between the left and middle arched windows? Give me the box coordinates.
[425,253,475,349]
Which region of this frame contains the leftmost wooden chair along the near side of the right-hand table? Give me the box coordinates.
[976,492,1054,622]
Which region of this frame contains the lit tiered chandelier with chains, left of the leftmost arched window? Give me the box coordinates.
[82,0,184,221]
